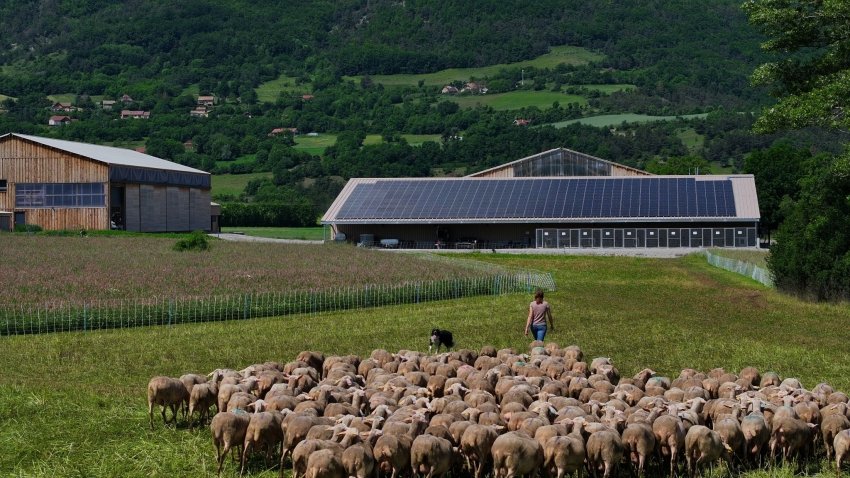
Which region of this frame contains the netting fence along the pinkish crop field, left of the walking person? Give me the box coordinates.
[0,271,555,335]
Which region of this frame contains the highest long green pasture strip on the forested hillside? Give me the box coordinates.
[346,46,604,86]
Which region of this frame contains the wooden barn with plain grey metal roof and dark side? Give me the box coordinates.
[0,133,215,232]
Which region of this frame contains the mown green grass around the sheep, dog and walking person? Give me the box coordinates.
[0,254,850,478]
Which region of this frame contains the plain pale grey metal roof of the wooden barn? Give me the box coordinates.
[0,133,209,175]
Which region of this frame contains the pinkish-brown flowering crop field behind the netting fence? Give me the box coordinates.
[0,234,490,305]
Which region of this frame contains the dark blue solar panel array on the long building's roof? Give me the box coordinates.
[335,177,736,220]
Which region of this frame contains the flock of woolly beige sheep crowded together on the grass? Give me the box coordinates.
[148,342,850,478]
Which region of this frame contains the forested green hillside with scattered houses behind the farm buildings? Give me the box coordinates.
[0,0,838,222]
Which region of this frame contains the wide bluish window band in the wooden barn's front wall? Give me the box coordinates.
[15,183,106,208]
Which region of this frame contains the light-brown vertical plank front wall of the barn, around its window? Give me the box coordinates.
[0,137,109,229]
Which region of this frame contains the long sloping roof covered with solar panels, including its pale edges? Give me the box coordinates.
[322,175,760,224]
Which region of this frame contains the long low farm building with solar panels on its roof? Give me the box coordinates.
[322,150,760,248]
